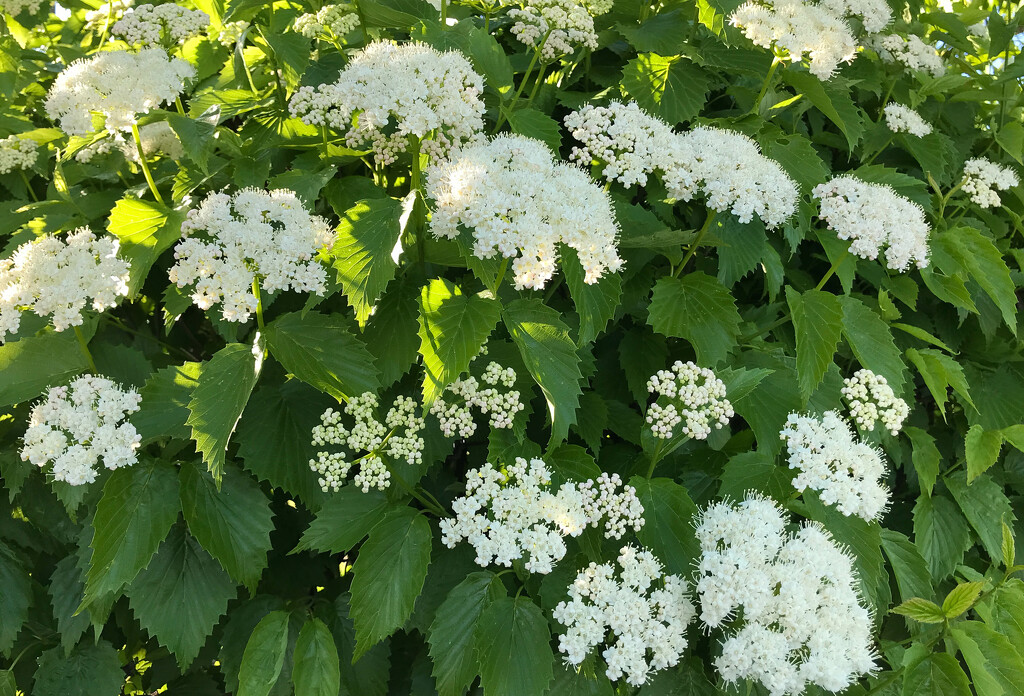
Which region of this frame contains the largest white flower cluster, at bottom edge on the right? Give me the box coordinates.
[696,495,874,696]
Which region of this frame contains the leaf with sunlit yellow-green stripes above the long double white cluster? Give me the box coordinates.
[622,53,711,126]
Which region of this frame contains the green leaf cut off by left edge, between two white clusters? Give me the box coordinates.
[0,330,89,406]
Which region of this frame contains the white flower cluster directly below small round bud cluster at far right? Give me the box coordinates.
[779,410,889,521]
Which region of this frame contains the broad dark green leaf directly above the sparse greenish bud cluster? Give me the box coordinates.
[266,312,380,401]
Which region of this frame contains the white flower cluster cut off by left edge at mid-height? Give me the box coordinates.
[0,227,129,344]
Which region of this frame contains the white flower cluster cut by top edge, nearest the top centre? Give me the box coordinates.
[508,0,603,62]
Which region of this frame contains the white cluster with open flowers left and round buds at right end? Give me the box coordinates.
[440,458,643,573]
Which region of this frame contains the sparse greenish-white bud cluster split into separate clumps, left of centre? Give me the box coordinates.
[309,392,424,492]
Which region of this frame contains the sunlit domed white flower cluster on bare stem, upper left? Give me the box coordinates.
[46,48,196,135]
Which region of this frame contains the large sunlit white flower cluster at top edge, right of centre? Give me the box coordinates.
[731,0,857,80]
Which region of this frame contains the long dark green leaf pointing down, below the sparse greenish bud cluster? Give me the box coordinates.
[351,508,431,659]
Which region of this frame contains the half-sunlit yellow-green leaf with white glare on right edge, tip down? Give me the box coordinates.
[331,198,401,327]
